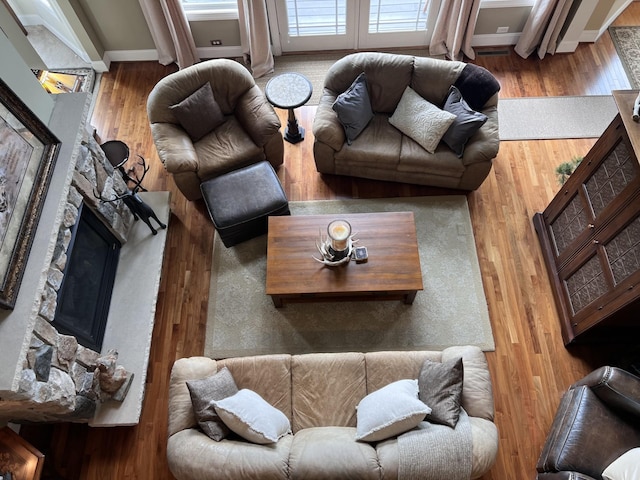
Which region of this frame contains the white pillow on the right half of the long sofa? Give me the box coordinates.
[356,380,431,442]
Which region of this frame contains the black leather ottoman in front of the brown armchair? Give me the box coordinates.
[200,161,290,247]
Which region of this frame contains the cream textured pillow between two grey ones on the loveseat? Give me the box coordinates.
[389,87,456,153]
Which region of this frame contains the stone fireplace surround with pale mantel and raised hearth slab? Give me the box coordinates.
[0,93,169,426]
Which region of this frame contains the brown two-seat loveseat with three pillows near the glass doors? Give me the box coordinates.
[313,52,500,191]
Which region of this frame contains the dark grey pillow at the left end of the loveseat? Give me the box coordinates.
[332,72,373,145]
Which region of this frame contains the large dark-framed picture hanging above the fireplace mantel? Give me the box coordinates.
[0,79,60,309]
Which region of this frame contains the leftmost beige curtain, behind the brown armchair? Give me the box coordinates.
[139,0,200,69]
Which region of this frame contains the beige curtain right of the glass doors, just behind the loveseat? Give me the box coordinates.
[429,0,480,60]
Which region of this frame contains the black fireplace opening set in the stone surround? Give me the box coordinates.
[53,205,121,352]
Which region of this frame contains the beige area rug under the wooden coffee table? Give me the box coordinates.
[204,196,495,358]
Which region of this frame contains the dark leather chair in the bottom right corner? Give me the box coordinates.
[536,366,640,480]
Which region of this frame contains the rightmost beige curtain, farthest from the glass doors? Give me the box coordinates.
[514,0,573,59]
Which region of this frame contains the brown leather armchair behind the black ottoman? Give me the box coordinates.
[147,59,284,200]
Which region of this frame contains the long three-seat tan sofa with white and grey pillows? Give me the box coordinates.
[167,346,498,480]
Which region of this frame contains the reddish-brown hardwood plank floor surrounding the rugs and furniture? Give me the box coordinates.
[20,2,640,480]
